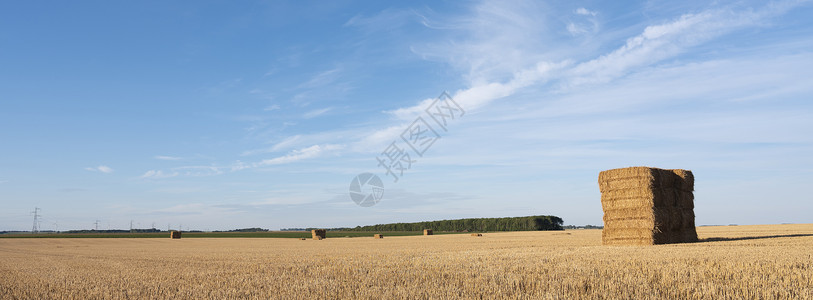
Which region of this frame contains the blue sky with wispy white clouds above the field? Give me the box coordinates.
[0,1,813,230]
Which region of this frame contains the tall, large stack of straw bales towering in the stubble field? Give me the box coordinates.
[598,167,697,245]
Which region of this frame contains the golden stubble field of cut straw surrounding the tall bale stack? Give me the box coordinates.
[0,224,813,299]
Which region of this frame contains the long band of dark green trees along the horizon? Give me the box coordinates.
[346,216,564,231]
